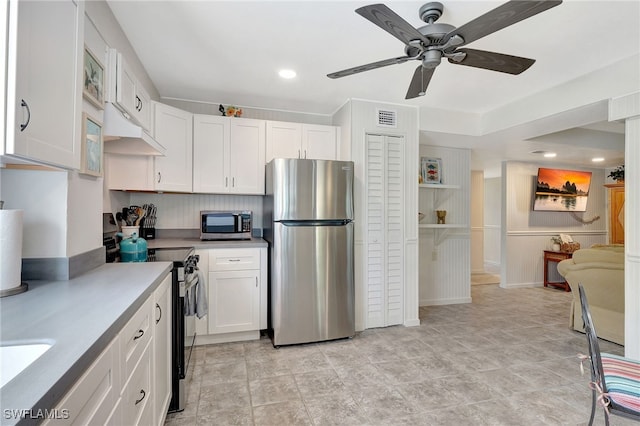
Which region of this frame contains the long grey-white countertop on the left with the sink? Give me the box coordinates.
[0,262,171,425]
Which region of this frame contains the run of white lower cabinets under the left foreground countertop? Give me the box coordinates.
[43,274,171,426]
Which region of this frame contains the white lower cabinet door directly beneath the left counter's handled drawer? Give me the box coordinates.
[121,344,153,425]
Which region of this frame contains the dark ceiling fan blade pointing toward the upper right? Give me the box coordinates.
[443,0,562,44]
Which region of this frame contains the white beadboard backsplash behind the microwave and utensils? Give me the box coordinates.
[130,193,263,229]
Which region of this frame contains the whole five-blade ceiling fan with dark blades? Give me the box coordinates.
[327,0,562,99]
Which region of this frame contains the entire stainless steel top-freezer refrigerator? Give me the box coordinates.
[264,158,355,346]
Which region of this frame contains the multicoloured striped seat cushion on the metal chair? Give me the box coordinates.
[602,353,640,413]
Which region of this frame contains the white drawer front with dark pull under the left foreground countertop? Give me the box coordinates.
[120,299,152,383]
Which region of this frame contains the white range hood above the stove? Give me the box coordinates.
[103,102,167,156]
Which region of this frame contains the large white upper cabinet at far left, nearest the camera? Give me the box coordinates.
[3,0,84,169]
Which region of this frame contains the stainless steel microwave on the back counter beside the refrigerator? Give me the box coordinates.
[200,210,253,240]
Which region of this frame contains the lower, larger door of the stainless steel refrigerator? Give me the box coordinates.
[271,222,355,346]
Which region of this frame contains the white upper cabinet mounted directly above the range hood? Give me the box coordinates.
[109,49,151,131]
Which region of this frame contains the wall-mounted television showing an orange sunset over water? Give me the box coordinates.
[533,167,591,212]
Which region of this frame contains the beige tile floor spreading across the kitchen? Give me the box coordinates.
[166,285,633,426]
